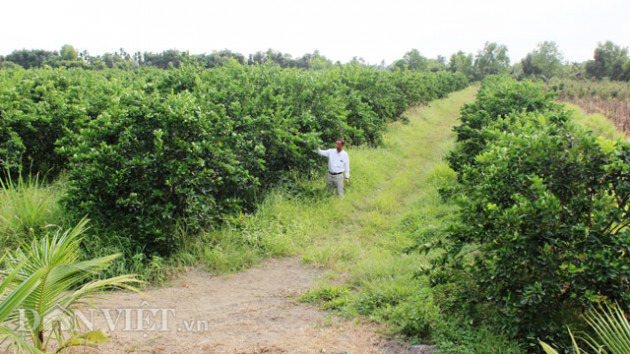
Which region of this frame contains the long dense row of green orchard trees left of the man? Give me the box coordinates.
[0,62,467,255]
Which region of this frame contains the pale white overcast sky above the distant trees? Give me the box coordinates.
[0,0,630,64]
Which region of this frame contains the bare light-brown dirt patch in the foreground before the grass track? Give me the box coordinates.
[85,258,431,353]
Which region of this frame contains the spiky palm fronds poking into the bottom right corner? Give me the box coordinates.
[540,304,630,354]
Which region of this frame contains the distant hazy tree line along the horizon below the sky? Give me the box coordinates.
[0,41,630,81]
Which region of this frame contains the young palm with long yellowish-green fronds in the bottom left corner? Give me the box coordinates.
[0,219,140,352]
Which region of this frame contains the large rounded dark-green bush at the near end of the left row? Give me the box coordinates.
[66,90,256,255]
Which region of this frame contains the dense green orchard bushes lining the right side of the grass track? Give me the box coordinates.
[431,78,630,339]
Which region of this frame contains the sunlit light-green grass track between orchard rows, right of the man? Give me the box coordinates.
[304,89,475,265]
